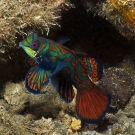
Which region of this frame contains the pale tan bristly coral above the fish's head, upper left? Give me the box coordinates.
[0,0,72,45]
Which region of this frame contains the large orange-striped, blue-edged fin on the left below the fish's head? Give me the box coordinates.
[25,66,51,94]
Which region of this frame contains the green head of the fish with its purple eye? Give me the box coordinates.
[19,33,41,58]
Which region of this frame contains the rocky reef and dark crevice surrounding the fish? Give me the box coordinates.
[0,0,135,135]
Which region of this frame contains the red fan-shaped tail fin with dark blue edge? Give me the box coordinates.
[76,84,111,123]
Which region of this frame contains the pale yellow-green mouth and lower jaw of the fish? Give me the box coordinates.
[19,42,36,58]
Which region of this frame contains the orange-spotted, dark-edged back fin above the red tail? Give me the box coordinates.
[77,53,103,82]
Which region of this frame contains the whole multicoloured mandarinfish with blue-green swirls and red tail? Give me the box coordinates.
[20,33,111,123]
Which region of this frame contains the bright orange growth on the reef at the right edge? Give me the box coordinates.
[123,7,135,27]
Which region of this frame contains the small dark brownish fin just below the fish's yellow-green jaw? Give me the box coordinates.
[25,56,38,68]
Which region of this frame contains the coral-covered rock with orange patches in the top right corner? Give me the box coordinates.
[98,0,135,39]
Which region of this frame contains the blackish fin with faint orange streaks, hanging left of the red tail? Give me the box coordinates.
[57,79,75,103]
